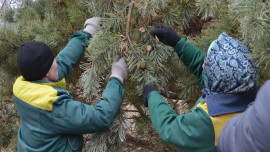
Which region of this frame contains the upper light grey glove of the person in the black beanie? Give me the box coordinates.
[83,17,101,36]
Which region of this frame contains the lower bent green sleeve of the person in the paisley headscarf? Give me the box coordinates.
[148,91,215,151]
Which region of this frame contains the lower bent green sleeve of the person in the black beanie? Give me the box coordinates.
[53,78,125,134]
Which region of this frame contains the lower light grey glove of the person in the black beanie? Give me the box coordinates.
[110,57,127,84]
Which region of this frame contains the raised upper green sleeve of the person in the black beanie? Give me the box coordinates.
[56,31,91,80]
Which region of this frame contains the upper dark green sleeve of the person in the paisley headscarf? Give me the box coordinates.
[174,38,205,85]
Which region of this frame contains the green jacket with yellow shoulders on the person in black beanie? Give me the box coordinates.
[13,31,124,152]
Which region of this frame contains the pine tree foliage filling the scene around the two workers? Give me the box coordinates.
[0,0,270,151]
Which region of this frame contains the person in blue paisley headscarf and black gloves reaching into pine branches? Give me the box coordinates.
[142,24,258,152]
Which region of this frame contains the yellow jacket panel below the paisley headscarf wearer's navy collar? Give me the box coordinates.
[197,102,242,146]
